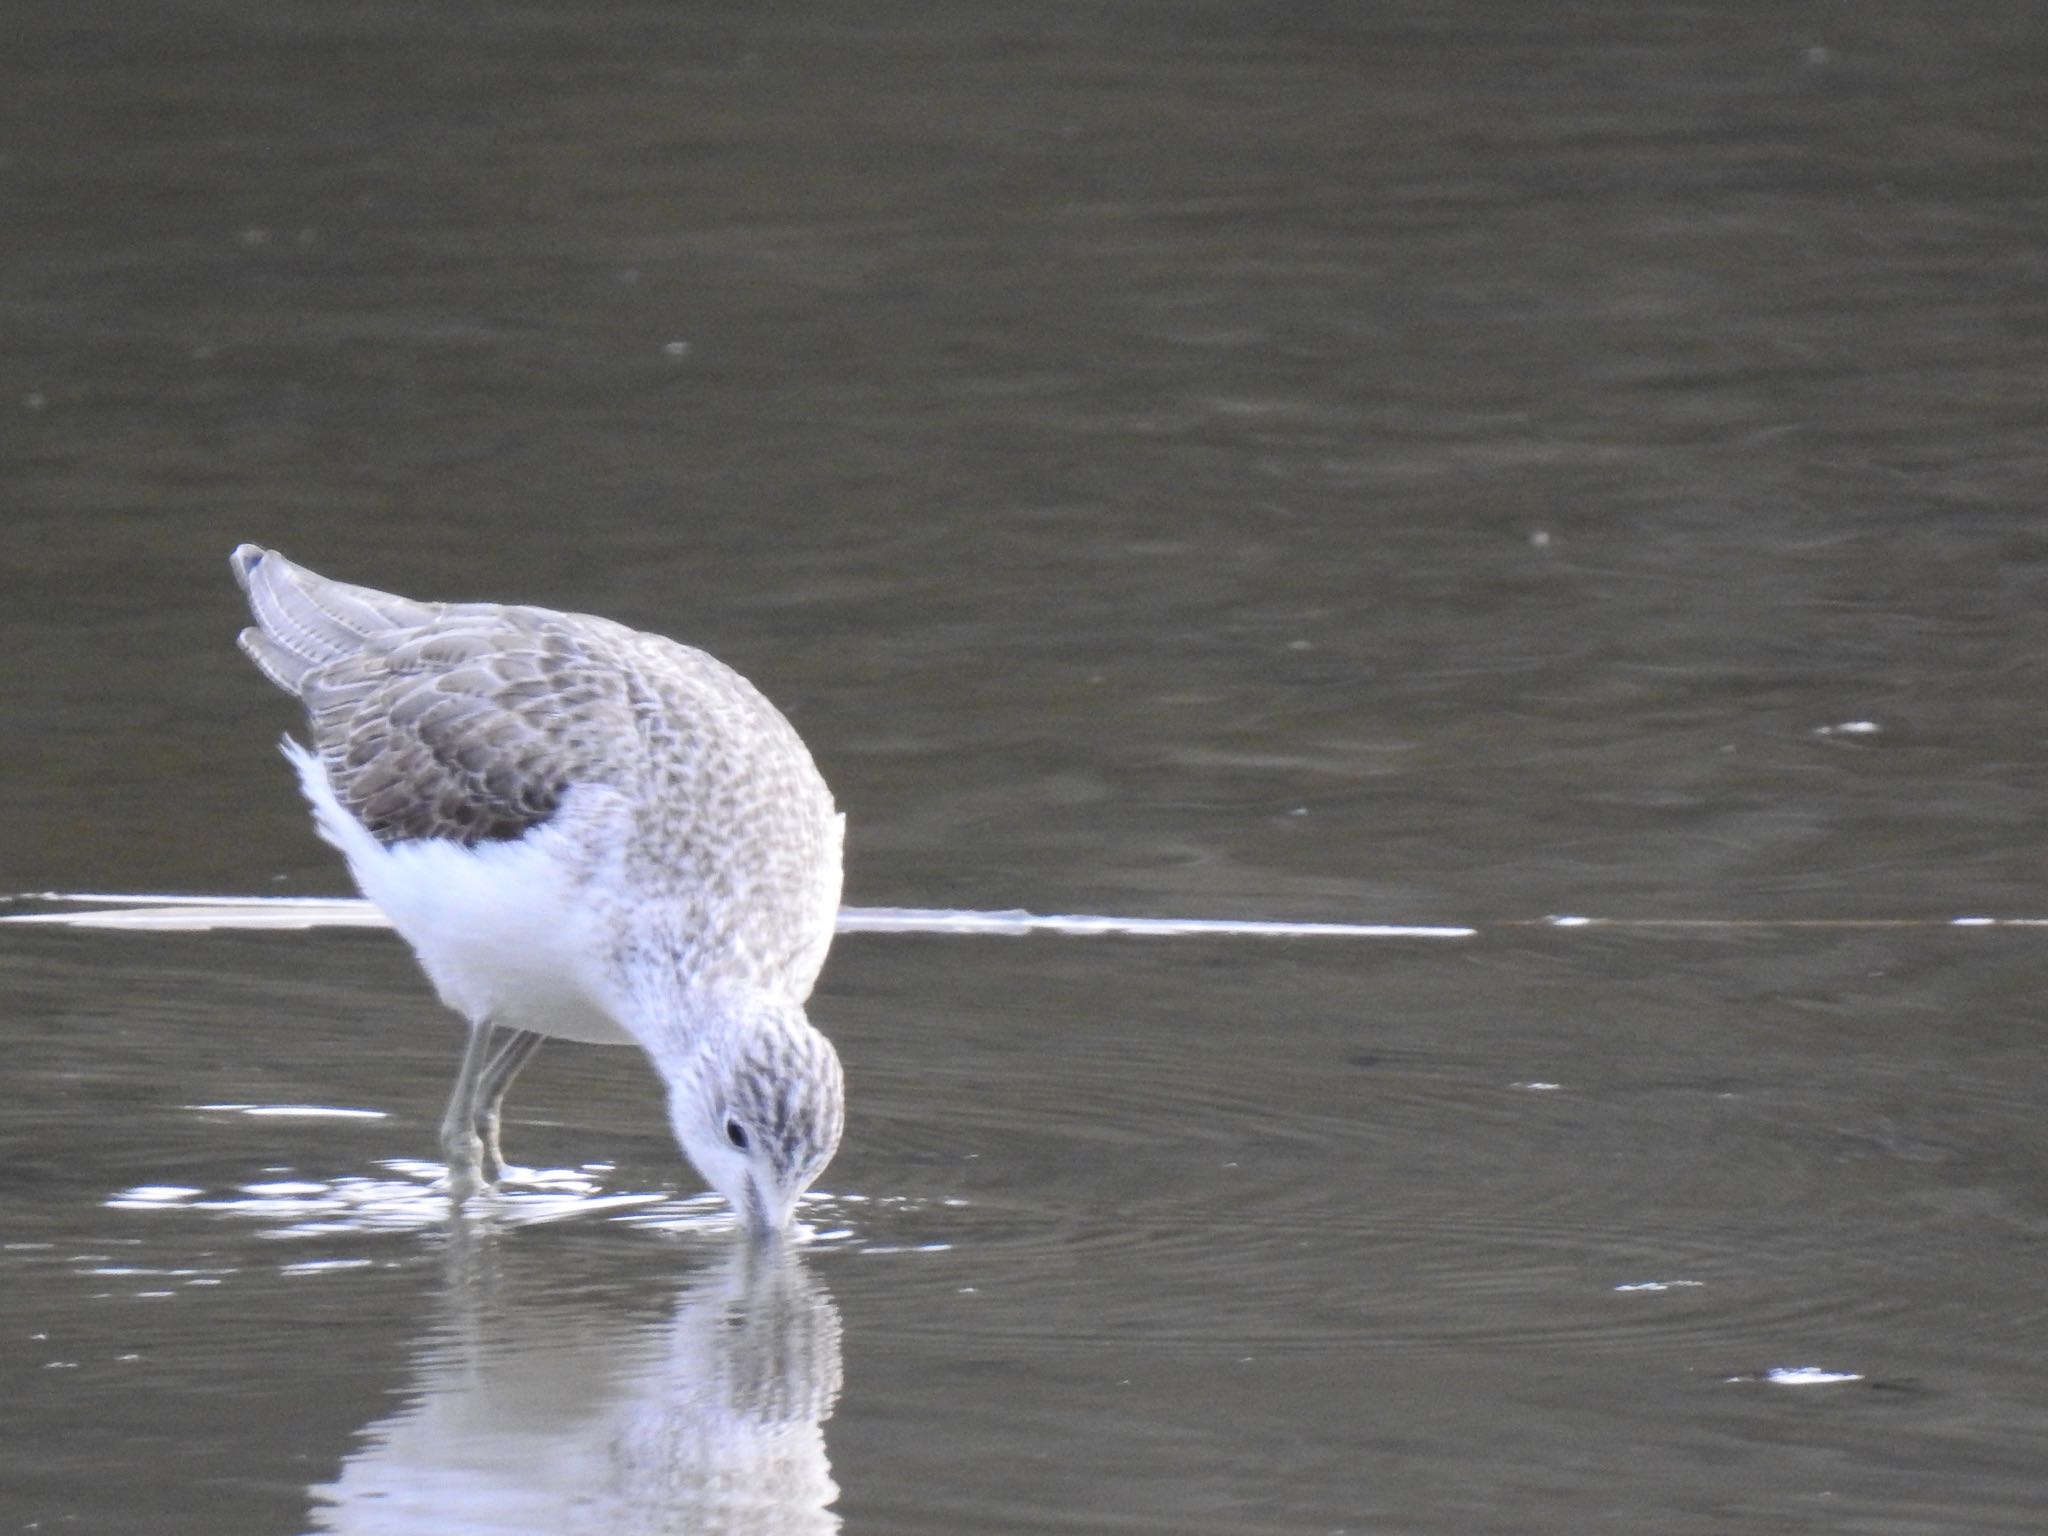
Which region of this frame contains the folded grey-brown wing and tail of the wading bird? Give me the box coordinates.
[233,545,637,846]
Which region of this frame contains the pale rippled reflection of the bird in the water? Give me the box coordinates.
[299,1245,840,1536]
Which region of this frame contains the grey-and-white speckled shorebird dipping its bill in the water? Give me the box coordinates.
[229,545,846,1233]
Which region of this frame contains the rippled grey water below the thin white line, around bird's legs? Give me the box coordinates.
[0,909,2048,1530]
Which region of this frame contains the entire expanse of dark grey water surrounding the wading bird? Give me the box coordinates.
[0,0,2048,1536]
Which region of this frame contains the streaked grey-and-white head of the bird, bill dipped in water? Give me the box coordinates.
[668,999,846,1237]
